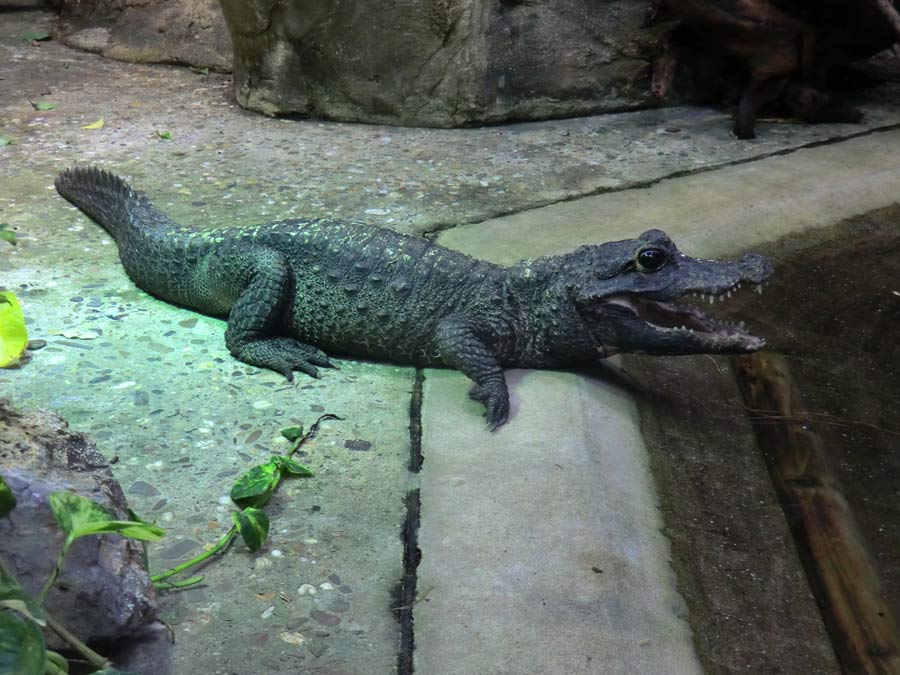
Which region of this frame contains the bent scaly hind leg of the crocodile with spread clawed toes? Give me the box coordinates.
[198,245,333,381]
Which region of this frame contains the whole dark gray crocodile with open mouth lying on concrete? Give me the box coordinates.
[56,167,772,430]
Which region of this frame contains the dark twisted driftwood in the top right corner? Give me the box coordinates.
[648,0,900,138]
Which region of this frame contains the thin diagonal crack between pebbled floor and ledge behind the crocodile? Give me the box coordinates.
[422,123,900,239]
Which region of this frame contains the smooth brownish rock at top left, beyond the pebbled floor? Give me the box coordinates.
[51,0,232,71]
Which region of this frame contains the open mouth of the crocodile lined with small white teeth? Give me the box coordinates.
[599,284,766,352]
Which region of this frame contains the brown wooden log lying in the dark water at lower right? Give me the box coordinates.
[738,353,900,675]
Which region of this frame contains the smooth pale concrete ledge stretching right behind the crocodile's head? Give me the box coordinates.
[438,129,900,264]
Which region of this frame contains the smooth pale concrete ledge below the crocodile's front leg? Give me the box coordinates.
[414,370,701,675]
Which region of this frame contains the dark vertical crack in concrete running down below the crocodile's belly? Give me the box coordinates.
[394,368,425,675]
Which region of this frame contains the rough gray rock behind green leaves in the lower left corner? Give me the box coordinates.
[0,399,157,647]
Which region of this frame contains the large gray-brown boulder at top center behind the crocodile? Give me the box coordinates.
[221,0,656,127]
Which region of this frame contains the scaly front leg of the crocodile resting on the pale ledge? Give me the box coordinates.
[435,316,509,431]
